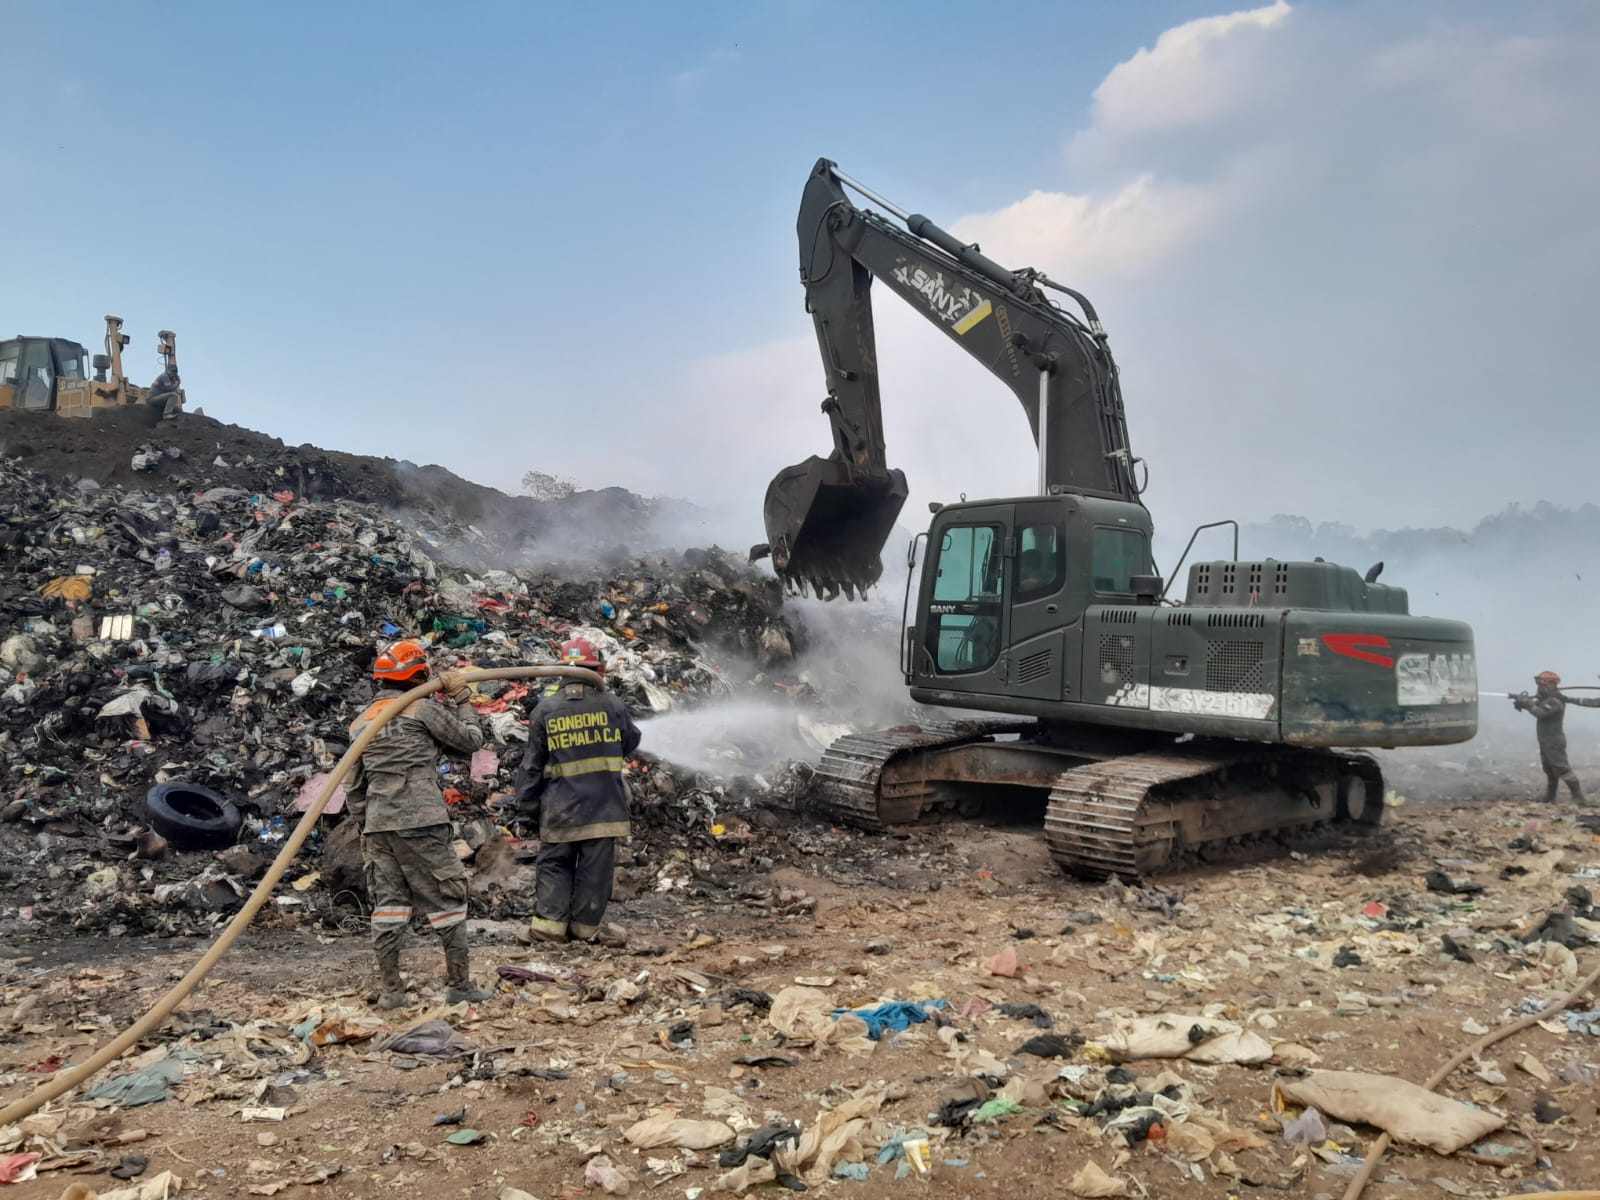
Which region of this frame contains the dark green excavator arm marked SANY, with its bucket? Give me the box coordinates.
[752,158,1139,598]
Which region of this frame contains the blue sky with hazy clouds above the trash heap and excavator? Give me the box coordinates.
[0,0,1600,541]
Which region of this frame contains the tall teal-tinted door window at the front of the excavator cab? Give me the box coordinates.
[928,525,1005,675]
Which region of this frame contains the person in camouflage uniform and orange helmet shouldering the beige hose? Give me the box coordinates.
[346,640,490,1008]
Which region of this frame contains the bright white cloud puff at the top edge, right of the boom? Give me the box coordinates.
[1094,0,1291,133]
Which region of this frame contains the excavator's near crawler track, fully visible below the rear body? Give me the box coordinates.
[1045,747,1384,878]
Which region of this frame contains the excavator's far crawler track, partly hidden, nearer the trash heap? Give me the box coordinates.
[808,720,1032,830]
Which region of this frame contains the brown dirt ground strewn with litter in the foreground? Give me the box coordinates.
[0,800,1600,1200]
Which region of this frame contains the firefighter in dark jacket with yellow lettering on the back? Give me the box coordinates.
[517,638,638,946]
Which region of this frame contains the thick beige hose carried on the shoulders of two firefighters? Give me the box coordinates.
[0,667,605,1126]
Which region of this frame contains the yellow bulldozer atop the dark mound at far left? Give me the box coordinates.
[0,317,184,418]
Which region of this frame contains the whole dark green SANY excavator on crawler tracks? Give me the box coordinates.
[750,158,1477,878]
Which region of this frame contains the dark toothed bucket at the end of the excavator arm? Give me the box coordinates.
[762,454,906,600]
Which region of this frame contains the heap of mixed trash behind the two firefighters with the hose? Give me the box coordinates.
[0,445,816,938]
